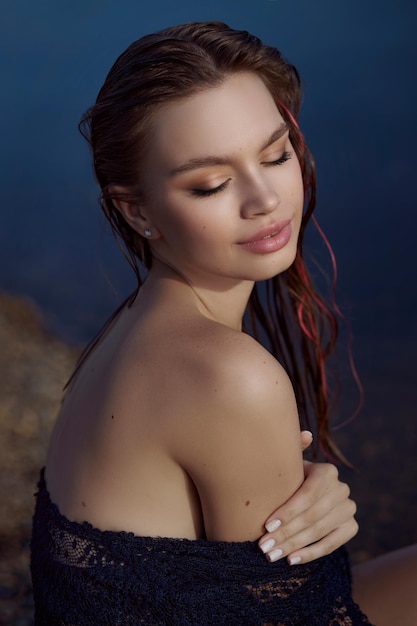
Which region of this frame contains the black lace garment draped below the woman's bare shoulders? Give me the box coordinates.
[31,472,369,626]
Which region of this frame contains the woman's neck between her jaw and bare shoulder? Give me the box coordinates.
[141,259,254,330]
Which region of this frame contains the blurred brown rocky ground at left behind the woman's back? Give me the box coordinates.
[0,294,80,624]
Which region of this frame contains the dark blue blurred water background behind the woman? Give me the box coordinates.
[0,0,417,552]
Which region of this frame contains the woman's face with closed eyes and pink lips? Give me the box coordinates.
[141,73,303,289]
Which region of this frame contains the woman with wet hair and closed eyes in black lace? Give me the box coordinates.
[32,23,414,625]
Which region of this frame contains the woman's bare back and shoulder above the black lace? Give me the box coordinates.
[46,272,303,540]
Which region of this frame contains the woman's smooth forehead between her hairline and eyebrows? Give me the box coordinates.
[145,73,283,166]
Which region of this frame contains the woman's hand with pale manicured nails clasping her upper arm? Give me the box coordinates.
[259,431,358,565]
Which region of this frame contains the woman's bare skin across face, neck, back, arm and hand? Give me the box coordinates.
[46,74,414,623]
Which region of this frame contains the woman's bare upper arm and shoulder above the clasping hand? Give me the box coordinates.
[171,338,303,541]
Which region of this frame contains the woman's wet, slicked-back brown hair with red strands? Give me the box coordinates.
[76,22,354,462]
